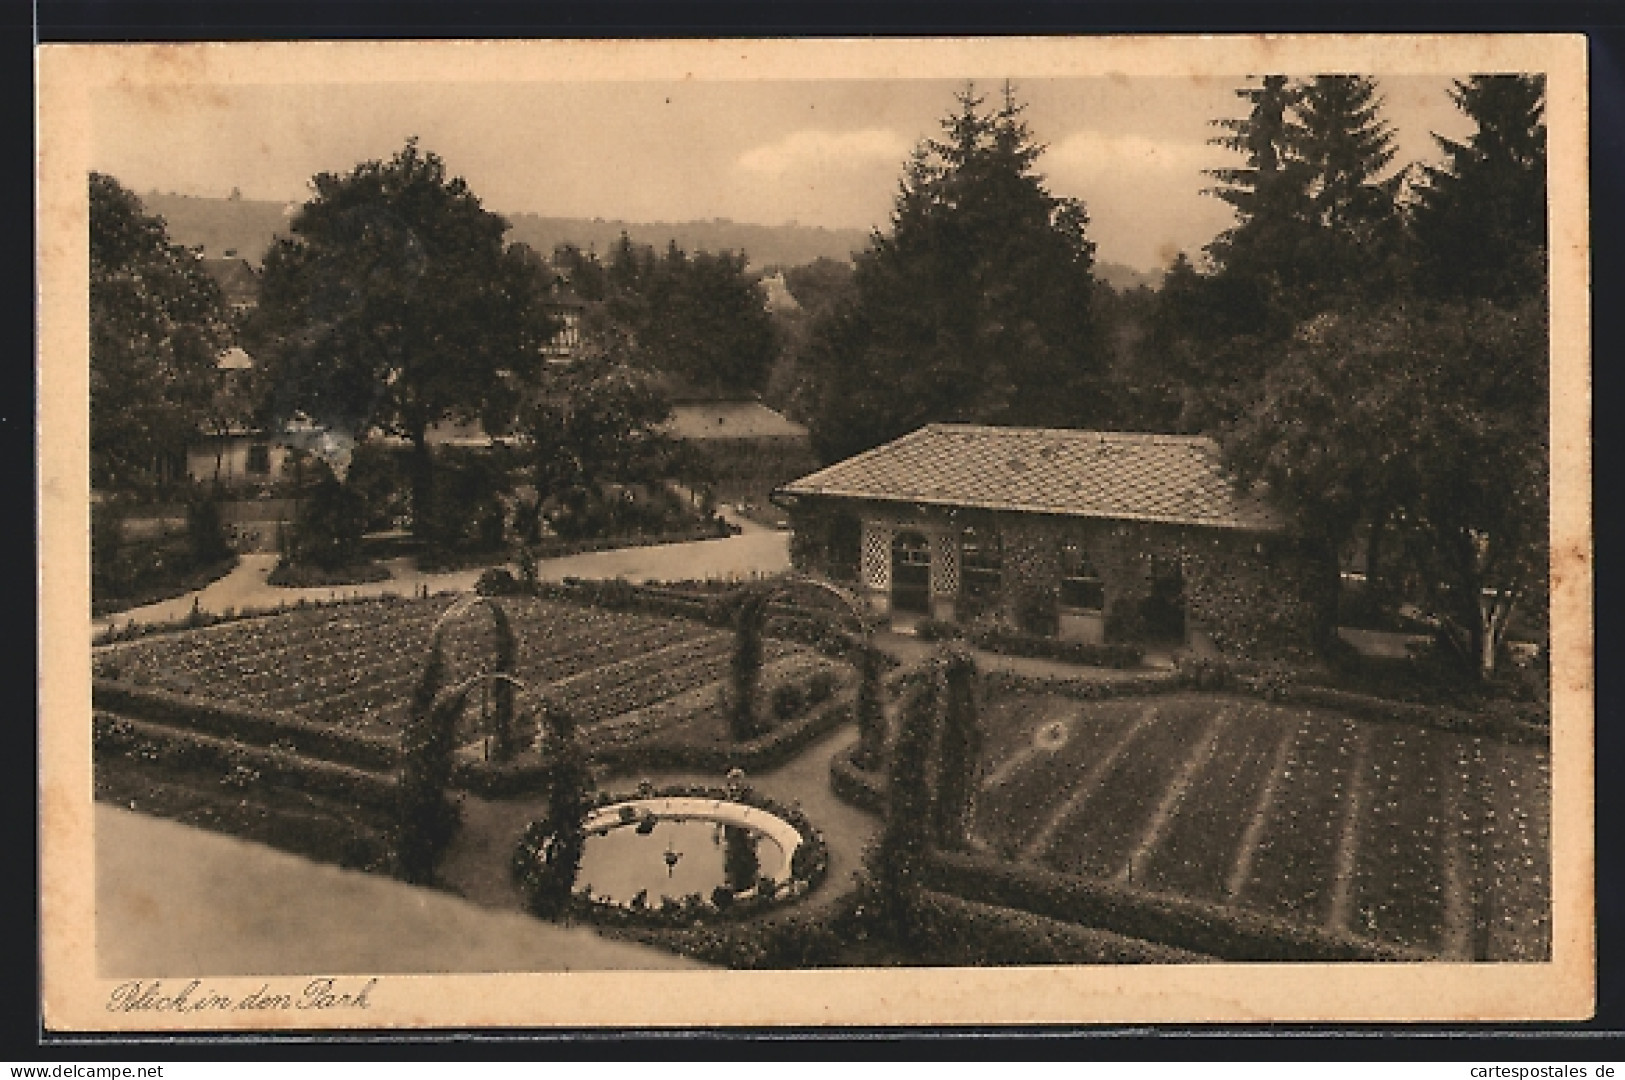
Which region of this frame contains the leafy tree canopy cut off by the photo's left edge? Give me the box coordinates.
[89,172,231,490]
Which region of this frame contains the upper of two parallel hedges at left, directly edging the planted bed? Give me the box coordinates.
[91,679,400,770]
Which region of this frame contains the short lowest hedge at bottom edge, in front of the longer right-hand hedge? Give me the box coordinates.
[908,888,1214,966]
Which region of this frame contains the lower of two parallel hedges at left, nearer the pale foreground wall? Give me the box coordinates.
[93,711,398,810]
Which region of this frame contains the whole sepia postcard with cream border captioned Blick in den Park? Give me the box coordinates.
[37,36,1596,1031]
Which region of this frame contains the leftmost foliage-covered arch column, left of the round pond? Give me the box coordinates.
[395,640,463,883]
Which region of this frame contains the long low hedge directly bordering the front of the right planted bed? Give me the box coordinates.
[921,849,1438,961]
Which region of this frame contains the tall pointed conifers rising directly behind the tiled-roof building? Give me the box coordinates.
[808,79,1107,458]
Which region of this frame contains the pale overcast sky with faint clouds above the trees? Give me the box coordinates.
[93,76,1467,270]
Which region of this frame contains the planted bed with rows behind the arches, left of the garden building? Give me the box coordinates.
[94,598,835,742]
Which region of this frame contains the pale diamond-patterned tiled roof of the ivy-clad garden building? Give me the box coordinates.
[780,424,1281,529]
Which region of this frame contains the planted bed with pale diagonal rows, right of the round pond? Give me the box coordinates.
[973,690,1550,960]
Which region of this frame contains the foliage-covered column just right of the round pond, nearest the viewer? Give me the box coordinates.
[869,659,943,939]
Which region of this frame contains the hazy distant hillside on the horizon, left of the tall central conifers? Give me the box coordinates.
[140,192,869,266]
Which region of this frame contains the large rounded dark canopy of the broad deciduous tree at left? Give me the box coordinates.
[249,140,551,457]
